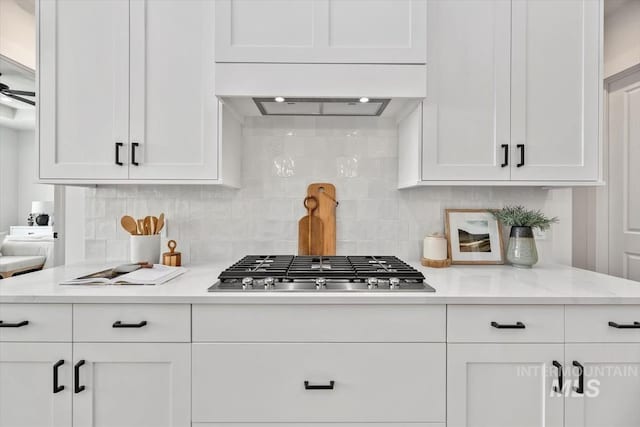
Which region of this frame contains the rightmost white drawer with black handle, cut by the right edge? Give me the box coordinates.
[565,305,640,342]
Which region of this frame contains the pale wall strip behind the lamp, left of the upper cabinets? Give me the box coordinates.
[17,130,54,225]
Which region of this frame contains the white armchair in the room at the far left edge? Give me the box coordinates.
[0,236,54,279]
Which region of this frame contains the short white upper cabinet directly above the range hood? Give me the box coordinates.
[215,0,427,64]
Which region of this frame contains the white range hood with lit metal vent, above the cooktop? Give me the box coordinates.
[215,63,427,118]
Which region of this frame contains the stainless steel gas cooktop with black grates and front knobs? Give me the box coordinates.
[209,255,435,292]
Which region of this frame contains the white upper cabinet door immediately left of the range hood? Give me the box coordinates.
[130,0,218,180]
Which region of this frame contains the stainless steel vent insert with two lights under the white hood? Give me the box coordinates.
[253,96,391,116]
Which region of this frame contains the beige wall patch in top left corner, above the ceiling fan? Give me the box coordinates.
[0,0,36,70]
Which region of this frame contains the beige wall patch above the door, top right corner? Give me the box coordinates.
[604,0,640,78]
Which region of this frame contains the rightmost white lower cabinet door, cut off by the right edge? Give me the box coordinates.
[565,344,640,427]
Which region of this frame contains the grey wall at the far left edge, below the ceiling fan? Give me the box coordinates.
[0,126,18,232]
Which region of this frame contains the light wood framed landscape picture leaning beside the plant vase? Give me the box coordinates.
[445,209,504,264]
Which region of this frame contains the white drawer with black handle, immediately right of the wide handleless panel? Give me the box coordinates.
[447,305,564,343]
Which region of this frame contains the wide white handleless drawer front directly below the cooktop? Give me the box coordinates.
[193,304,446,342]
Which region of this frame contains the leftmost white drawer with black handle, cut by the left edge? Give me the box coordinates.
[0,304,71,342]
